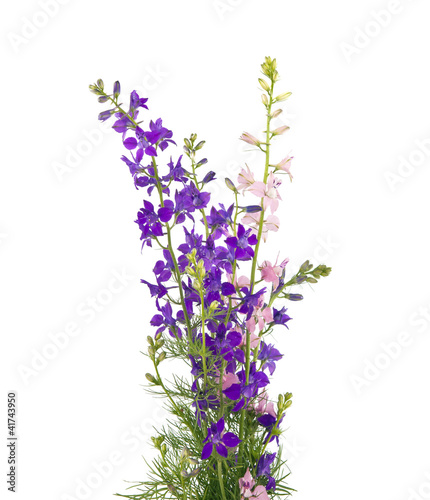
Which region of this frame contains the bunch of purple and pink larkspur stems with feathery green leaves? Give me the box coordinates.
[90,57,330,500]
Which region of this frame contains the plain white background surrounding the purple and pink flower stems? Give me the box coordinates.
[0,0,430,500]
